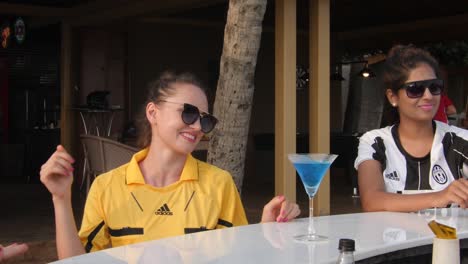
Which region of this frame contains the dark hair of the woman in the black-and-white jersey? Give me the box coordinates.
[382,44,440,126]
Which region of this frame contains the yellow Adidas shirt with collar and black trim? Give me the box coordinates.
[79,149,247,252]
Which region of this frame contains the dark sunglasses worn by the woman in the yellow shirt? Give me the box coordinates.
[160,100,218,134]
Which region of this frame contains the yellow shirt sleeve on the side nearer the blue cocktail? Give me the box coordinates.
[216,173,248,228]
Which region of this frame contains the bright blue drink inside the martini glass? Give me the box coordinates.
[293,161,331,197]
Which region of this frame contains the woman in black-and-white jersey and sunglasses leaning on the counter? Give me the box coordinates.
[355,45,468,211]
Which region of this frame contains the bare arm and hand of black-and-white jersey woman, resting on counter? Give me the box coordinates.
[358,160,468,212]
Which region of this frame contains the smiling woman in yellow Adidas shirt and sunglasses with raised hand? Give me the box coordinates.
[41,73,300,258]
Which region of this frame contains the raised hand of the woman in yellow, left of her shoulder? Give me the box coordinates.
[40,145,75,199]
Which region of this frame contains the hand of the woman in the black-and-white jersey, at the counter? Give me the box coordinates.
[434,179,468,208]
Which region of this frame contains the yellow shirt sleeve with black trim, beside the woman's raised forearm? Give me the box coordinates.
[78,177,110,252]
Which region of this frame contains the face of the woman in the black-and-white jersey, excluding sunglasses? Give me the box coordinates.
[387,63,440,122]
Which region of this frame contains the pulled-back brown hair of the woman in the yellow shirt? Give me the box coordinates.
[137,71,206,148]
